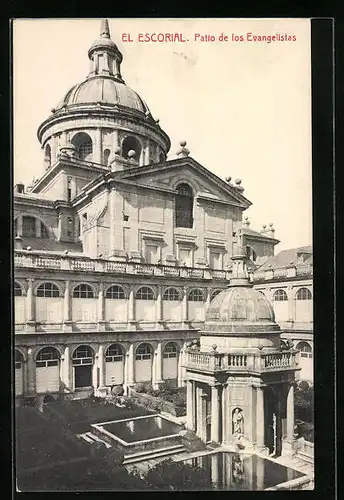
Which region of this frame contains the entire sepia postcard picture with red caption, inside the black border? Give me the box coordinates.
[11,18,315,492]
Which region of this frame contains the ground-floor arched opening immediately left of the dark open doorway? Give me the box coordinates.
[36,347,60,394]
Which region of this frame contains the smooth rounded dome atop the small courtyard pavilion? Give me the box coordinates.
[204,285,279,334]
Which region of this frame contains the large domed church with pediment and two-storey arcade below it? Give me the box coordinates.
[14,21,278,397]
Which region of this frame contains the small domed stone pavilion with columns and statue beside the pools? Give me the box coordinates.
[185,251,299,456]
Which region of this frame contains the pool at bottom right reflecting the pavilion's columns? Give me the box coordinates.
[183,452,307,491]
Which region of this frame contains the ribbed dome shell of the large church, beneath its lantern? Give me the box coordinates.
[56,75,149,113]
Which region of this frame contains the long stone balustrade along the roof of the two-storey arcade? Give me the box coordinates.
[14,250,231,281]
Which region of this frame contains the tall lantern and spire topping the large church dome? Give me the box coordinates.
[87,19,124,83]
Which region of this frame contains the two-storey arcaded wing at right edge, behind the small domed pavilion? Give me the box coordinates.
[253,246,314,383]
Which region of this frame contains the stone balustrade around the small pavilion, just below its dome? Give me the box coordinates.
[184,350,298,372]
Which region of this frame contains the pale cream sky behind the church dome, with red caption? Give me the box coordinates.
[13,19,312,251]
